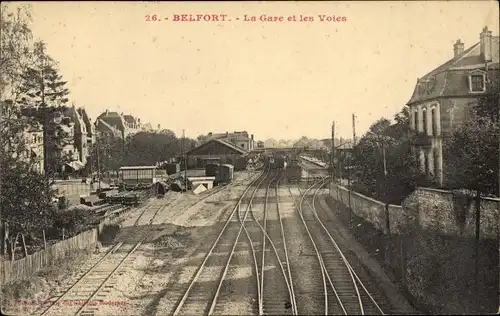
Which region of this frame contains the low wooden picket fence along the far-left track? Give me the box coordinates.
[0,217,121,284]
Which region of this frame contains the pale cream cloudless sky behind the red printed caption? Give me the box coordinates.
[20,1,499,140]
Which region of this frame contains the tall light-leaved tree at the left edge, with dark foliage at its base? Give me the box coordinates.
[0,3,60,252]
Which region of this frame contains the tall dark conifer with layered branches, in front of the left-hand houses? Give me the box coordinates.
[16,42,71,175]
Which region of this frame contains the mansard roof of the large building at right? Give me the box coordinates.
[407,36,500,105]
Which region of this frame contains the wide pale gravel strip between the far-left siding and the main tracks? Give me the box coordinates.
[80,173,262,315]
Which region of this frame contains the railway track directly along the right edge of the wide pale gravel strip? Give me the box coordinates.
[173,169,267,315]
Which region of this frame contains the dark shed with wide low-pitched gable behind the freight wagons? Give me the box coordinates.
[187,139,248,169]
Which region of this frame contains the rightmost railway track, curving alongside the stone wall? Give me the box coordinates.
[298,179,384,315]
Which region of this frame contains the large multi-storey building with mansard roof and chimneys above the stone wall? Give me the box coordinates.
[407,27,499,184]
